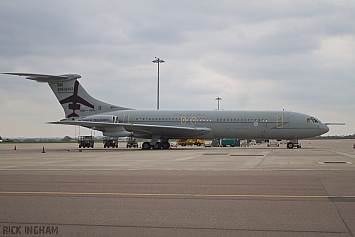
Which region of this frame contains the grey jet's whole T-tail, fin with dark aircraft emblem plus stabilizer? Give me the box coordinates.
[3,73,132,118]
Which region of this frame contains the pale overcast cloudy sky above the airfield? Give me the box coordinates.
[0,0,355,138]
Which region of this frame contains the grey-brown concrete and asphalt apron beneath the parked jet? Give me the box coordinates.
[0,140,355,236]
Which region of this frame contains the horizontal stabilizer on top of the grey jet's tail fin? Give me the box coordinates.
[2,72,81,83]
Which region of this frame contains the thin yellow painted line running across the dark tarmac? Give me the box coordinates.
[0,192,355,199]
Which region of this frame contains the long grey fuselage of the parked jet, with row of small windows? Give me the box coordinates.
[88,110,329,140]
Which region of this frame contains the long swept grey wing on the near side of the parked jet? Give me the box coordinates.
[49,121,212,138]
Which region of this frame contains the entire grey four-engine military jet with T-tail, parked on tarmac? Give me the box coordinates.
[3,73,330,150]
